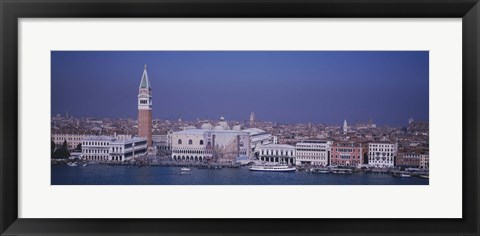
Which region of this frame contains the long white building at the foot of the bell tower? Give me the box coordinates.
[82,136,147,161]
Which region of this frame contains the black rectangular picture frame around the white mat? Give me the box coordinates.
[0,0,480,235]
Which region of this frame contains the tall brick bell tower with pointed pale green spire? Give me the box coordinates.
[138,65,152,149]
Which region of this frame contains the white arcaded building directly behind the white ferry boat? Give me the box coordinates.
[258,144,295,165]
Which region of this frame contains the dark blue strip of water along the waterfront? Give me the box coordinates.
[51,164,428,185]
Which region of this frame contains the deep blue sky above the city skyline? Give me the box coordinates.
[51,51,429,126]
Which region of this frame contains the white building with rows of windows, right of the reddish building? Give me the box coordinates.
[368,142,398,167]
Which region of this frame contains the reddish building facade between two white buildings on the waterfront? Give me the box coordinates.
[330,142,368,167]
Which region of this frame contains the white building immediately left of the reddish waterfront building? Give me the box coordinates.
[295,140,333,166]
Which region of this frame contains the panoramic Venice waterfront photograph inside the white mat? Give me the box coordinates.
[50,50,429,186]
